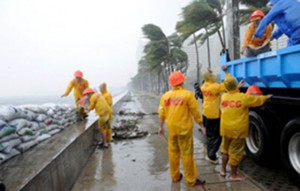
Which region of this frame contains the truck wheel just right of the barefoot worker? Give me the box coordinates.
[246,111,268,163]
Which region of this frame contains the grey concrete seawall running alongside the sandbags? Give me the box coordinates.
[0,92,127,191]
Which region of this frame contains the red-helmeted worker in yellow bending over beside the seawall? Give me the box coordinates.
[83,88,112,148]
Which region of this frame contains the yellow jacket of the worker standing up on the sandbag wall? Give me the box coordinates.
[64,78,89,102]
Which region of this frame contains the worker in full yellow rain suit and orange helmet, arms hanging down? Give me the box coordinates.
[158,72,205,186]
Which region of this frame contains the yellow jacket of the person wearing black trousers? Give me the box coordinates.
[201,73,230,119]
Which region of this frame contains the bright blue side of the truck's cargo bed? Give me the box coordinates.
[220,45,300,88]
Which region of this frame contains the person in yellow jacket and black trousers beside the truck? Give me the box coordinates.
[201,65,230,164]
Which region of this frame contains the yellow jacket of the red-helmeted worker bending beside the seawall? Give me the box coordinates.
[87,93,112,121]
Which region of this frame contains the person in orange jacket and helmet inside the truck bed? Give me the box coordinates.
[241,10,273,56]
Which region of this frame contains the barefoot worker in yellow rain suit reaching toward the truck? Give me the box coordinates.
[220,77,271,180]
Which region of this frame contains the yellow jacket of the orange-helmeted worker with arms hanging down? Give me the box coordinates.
[158,86,202,136]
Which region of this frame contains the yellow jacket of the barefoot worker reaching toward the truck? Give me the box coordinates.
[220,90,268,139]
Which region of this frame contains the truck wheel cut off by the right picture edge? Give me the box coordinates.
[280,118,300,185]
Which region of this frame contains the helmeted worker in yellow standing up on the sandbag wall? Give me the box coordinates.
[61,70,89,119]
